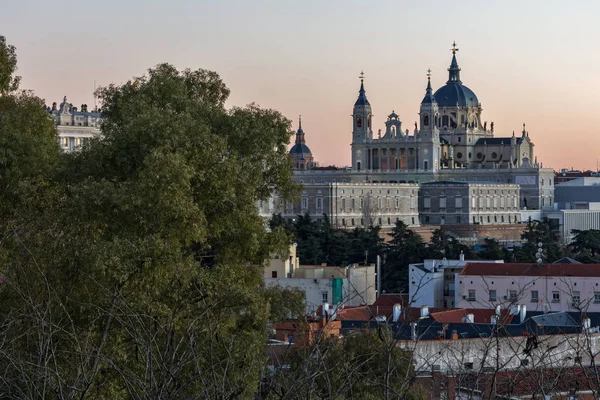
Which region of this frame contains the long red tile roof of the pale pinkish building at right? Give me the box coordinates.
[460,262,600,278]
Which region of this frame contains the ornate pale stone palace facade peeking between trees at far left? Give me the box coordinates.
[47,96,102,152]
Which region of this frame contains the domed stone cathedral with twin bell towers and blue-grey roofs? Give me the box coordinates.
[293,42,554,214]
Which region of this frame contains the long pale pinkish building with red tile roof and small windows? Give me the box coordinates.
[455,262,600,313]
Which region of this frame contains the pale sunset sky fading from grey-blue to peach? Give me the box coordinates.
[0,0,600,170]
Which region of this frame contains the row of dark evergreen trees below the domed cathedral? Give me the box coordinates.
[270,214,600,292]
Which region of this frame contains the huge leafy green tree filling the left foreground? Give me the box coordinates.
[0,64,297,399]
